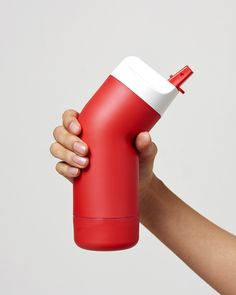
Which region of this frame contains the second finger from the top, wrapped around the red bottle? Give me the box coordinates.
[53,126,88,156]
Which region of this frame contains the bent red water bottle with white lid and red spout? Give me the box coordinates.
[73,56,192,250]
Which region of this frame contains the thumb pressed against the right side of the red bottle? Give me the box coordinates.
[135,131,158,168]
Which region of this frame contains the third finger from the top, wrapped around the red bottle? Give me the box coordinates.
[50,142,89,168]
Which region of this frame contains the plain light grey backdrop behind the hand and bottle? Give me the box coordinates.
[0,0,236,295]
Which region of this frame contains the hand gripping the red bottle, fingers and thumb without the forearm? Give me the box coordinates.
[50,109,157,202]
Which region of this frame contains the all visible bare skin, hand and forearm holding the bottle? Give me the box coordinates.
[50,109,236,295]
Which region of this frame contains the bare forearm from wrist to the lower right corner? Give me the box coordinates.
[140,177,236,295]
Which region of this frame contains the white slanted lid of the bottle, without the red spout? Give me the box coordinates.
[111,56,179,115]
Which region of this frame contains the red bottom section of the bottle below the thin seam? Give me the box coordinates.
[73,216,139,251]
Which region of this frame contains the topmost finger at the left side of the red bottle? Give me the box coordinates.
[62,109,81,135]
